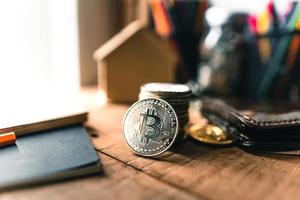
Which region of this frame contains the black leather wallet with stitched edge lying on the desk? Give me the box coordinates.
[201,98,300,151]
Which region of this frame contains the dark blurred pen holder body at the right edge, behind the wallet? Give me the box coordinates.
[244,29,300,103]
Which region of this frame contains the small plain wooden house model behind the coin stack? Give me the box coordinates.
[94,20,176,102]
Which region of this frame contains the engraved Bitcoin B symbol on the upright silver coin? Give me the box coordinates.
[140,108,161,144]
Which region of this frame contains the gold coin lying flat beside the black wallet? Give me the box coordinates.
[186,124,233,145]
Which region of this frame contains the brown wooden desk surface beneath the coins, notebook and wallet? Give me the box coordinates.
[0,89,300,200]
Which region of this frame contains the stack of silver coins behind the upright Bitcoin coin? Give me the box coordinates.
[139,83,192,138]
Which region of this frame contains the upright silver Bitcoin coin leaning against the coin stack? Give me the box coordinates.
[123,98,178,156]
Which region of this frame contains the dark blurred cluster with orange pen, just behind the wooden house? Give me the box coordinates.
[149,0,208,83]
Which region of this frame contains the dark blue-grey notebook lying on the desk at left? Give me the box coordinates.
[0,124,100,189]
